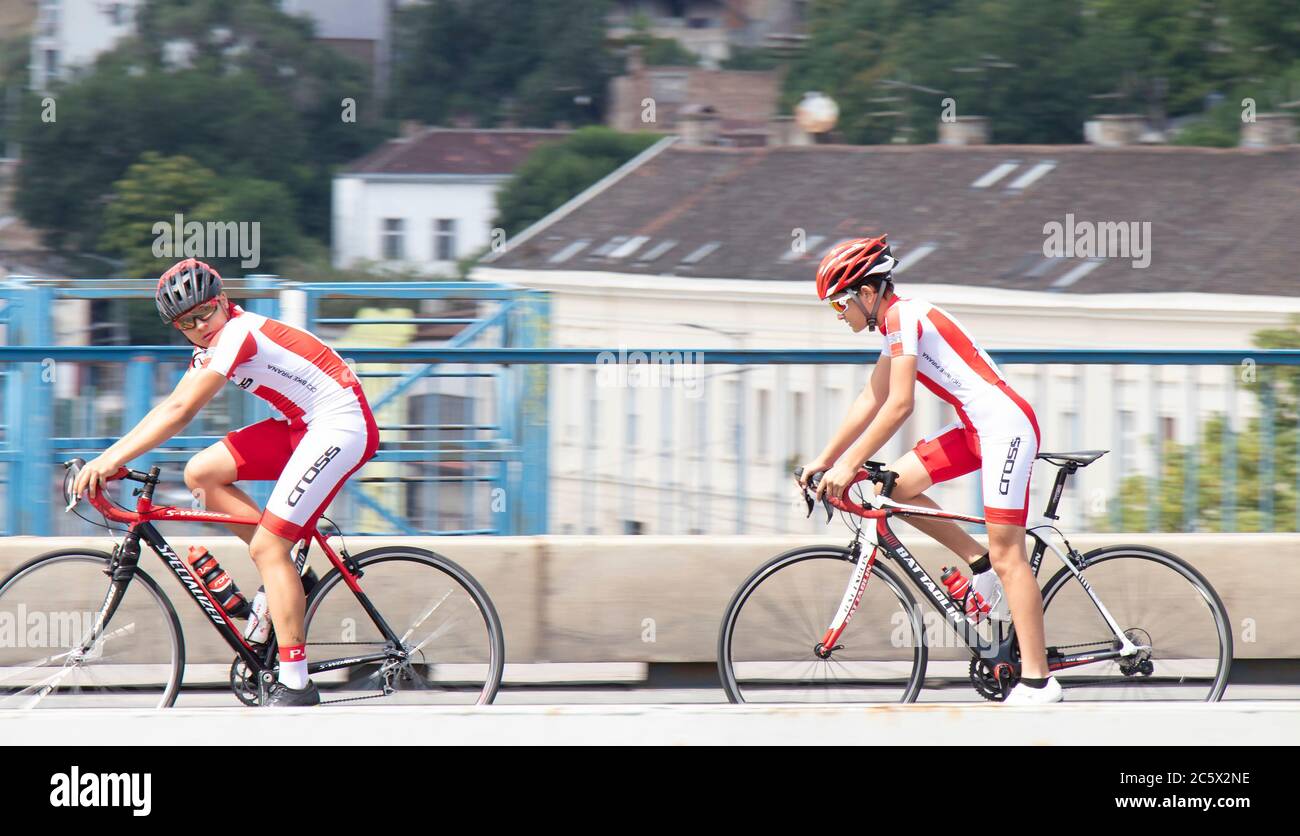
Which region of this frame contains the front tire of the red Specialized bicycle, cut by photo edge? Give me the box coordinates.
[0,549,185,709]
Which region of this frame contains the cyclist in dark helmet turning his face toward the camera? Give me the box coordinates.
[75,259,380,706]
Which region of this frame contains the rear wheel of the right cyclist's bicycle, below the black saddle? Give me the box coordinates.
[1043,546,1232,702]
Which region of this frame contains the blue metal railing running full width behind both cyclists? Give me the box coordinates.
[0,282,1300,533]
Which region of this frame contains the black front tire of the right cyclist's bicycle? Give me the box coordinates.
[718,546,928,703]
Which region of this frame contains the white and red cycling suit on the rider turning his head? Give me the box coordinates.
[190,306,380,540]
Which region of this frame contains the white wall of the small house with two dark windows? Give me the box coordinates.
[332,176,508,276]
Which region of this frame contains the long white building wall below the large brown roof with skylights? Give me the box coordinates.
[475,268,1300,534]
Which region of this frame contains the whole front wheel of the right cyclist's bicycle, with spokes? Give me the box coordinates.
[718,546,926,702]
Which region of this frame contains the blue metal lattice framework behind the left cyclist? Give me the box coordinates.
[0,276,547,534]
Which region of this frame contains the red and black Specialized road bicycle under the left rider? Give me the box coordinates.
[0,459,506,709]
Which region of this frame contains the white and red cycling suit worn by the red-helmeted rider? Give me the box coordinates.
[880,296,1040,525]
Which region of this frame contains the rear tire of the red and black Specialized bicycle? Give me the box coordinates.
[303,546,506,705]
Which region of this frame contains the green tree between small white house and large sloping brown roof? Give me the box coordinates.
[494,126,660,235]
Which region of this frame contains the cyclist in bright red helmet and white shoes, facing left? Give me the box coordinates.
[801,235,1061,705]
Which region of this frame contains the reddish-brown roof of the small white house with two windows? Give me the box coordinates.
[343,127,569,174]
